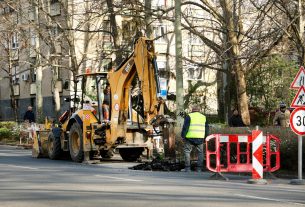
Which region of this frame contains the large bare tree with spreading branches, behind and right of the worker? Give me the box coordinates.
[159,0,284,125]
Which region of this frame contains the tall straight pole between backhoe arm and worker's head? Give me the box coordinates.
[175,0,184,129]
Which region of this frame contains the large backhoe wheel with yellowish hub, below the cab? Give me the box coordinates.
[69,123,84,162]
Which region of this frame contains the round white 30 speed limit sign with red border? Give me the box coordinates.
[289,107,305,135]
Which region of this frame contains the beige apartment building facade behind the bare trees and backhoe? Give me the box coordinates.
[0,0,217,120]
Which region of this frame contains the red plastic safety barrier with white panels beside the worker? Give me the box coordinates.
[206,134,280,173]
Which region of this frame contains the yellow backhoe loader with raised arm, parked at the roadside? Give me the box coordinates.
[33,37,173,162]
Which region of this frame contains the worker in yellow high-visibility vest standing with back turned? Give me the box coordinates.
[181,106,209,172]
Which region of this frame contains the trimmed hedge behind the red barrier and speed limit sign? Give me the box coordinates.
[210,125,305,173]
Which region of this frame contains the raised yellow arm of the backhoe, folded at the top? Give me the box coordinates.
[107,37,159,147]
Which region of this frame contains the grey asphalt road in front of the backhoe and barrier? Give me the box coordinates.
[0,145,305,207]
